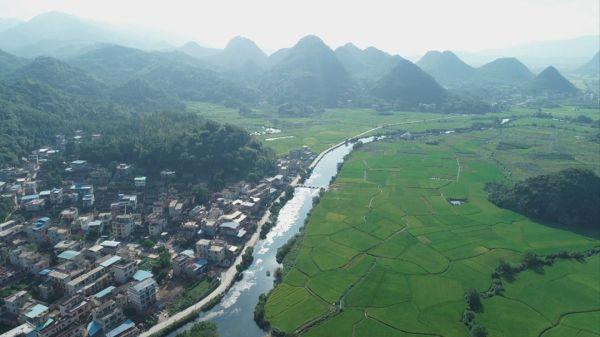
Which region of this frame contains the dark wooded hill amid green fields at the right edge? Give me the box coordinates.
[487,168,600,229]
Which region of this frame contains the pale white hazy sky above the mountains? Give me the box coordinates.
[0,0,600,55]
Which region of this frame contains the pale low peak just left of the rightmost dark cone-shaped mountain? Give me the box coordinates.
[477,57,535,85]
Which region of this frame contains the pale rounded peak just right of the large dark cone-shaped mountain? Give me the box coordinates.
[417,50,477,86]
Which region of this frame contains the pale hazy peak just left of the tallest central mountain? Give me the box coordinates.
[208,36,268,69]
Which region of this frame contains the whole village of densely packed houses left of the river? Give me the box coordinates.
[0,131,316,337]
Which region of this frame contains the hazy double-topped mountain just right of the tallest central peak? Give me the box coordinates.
[335,43,402,80]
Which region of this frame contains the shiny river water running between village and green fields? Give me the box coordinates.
[169,137,373,337]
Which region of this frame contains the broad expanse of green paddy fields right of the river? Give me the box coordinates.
[265,112,600,337]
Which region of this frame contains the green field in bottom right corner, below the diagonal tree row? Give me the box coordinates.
[479,255,600,337]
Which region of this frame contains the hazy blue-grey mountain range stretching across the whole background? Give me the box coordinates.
[0,9,598,113]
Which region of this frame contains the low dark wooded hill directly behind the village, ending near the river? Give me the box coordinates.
[69,113,276,188]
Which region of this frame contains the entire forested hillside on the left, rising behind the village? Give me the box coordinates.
[0,50,275,186]
